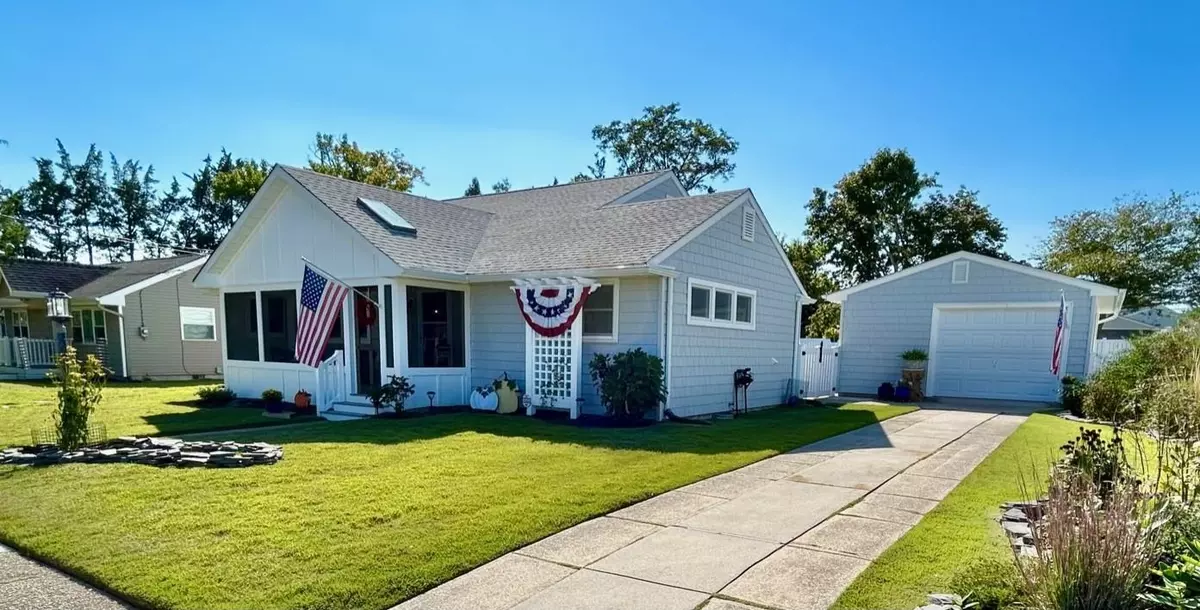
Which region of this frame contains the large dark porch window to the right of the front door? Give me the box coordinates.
[406,286,467,369]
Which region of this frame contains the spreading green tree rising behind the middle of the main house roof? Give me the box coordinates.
[588,103,738,192]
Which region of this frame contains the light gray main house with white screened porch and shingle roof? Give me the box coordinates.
[196,166,810,417]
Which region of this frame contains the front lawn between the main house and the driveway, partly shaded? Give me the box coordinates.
[0,403,911,610]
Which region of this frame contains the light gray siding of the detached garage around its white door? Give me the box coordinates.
[838,261,1096,394]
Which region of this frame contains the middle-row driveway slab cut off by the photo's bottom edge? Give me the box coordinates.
[514,569,708,610]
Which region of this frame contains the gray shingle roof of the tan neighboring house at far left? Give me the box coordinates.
[0,255,200,299]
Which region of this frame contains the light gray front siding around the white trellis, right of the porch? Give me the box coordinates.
[470,276,661,413]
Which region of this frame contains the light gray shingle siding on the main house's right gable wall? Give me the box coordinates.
[664,207,800,415]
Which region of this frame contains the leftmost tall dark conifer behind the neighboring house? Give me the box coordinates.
[19,157,79,261]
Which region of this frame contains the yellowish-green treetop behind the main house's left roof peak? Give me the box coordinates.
[308,133,425,192]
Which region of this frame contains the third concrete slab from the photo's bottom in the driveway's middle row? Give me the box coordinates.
[680,480,866,544]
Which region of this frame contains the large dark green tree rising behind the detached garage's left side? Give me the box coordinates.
[805,148,1007,285]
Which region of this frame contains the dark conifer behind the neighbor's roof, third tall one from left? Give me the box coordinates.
[98,155,160,261]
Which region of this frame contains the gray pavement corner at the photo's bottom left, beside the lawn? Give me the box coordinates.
[0,545,128,610]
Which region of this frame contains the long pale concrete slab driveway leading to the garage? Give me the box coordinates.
[394,409,1025,610]
